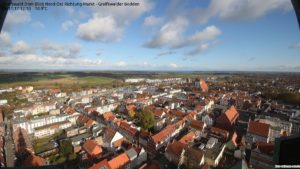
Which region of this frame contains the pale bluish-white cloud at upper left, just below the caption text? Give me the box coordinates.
[3,10,31,31]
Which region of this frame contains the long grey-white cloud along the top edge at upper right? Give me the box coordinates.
[191,0,292,23]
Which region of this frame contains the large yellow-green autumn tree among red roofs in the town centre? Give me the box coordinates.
[137,109,155,130]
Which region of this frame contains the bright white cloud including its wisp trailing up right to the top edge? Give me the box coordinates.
[76,0,152,42]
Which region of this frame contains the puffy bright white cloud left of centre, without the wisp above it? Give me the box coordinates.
[76,14,122,42]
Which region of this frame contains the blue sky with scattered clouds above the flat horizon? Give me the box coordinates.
[0,0,300,72]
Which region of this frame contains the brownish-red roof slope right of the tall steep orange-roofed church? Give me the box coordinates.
[247,121,270,137]
